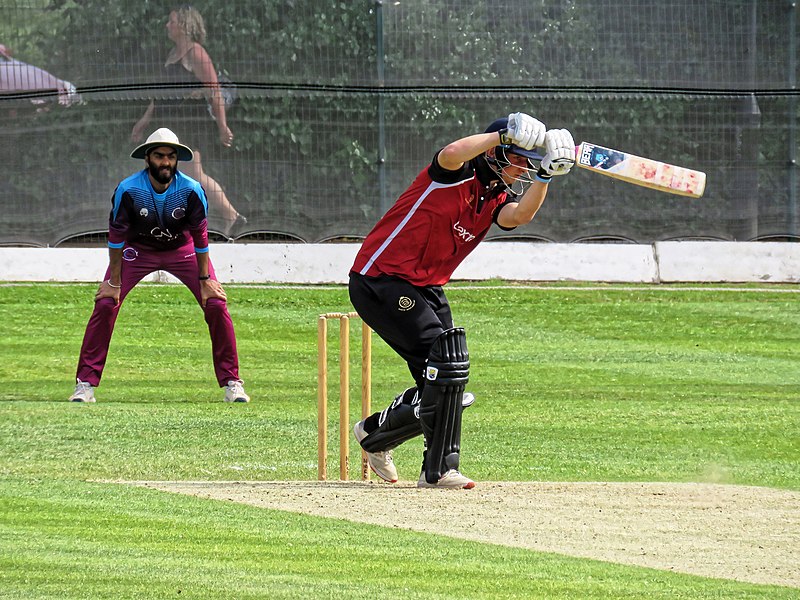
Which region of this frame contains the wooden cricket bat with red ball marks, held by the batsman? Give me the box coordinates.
[575,142,706,198]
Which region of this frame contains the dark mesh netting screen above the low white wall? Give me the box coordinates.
[0,0,798,245]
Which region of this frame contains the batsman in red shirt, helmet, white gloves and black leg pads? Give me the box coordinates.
[349,112,575,489]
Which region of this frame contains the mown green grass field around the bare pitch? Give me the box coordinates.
[0,282,800,599]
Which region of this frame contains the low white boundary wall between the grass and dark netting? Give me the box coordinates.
[0,242,800,284]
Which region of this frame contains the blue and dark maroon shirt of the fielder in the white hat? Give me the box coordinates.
[108,169,208,252]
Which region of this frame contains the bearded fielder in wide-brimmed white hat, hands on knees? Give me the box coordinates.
[70,128,250,402]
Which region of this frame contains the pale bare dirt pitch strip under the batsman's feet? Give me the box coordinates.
[129,481,800,588]
